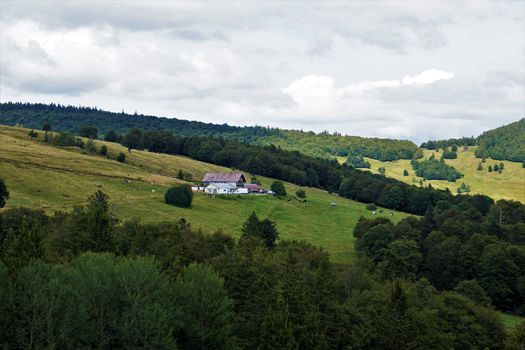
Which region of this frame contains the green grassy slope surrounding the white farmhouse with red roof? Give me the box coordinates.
[0,126,407,262]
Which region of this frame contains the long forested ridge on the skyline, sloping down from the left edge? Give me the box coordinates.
[0,102,419,161]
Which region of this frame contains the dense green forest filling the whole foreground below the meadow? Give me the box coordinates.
[0,185,525,350]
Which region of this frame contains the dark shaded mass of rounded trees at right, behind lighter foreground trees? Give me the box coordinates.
[354,201,525,314]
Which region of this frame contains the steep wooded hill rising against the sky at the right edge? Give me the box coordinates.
[476,119,525,162]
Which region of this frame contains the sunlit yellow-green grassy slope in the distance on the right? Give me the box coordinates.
[339,147,525,203]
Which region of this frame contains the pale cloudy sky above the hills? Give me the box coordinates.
[0,0,525,143]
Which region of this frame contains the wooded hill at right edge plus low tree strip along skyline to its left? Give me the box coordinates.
[421,119,525,162]
